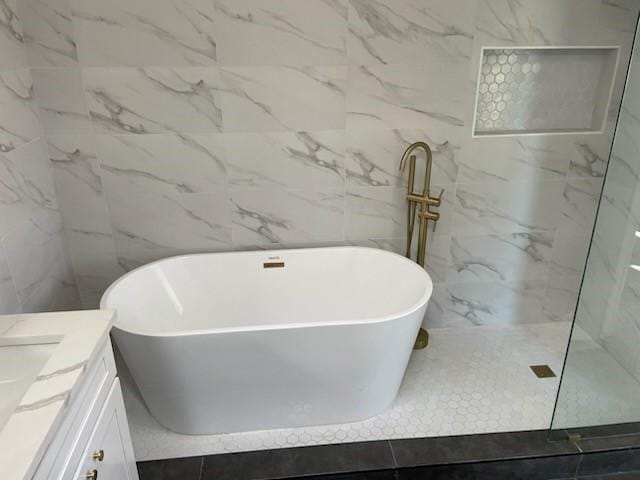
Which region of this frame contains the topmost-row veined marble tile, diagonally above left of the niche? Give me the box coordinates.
[348,0,476,65]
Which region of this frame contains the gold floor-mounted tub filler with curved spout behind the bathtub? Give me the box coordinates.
[400,142,444,350]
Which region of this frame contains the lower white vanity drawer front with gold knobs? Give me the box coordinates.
[72,378,138,480]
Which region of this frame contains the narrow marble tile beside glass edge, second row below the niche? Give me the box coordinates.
[558,178,602,237]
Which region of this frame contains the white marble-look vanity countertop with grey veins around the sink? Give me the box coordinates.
[0,310,115,480]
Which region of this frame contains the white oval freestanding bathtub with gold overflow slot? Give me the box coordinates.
[101,247,433,434]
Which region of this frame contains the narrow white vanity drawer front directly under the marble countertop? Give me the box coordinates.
[33,341,116,480]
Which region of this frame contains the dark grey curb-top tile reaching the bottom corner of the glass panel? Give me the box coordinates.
[390,430,579,467]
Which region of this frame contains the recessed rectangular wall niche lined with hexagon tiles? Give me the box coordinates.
[473,47,619,136]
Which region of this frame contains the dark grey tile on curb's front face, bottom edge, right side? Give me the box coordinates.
[398,455,579,480]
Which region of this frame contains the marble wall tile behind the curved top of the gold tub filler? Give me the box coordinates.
[347,126,464,188]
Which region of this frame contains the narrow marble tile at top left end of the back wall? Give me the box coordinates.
[20,0,78,67]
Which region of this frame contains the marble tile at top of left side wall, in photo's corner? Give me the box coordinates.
[0,0,27,72]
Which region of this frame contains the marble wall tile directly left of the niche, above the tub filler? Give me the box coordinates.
[347,62,470,129]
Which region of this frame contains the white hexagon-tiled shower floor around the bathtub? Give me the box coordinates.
[122,323,640,460]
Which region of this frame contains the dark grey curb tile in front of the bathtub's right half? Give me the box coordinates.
[202,441,394,480]
